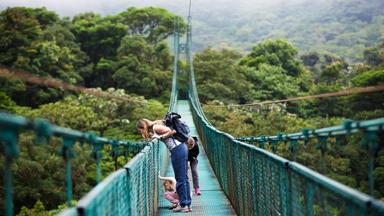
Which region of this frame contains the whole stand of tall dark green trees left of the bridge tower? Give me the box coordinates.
[0,7,182,107]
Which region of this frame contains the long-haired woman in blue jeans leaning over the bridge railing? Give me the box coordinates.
[136,119,192,212]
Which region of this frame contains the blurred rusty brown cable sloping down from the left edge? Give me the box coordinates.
[0,65,146,103]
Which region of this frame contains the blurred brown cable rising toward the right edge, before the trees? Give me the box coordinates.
[205,85,384,107]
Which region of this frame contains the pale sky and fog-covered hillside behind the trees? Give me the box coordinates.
[0,0,384,62]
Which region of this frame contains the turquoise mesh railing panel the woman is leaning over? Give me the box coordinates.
[62,141,167,216]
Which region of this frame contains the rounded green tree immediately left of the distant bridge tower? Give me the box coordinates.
[112,35,172,101]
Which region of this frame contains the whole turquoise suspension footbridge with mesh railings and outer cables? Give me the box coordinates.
[0,8,384,216]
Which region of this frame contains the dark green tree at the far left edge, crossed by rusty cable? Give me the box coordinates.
[0,7,84,106]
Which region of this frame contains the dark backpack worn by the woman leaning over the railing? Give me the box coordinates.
[164,112,190,143]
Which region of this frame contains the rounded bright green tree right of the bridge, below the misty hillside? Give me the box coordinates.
[240,40,311,100]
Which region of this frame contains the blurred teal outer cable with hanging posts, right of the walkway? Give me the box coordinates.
[237,118,384,196]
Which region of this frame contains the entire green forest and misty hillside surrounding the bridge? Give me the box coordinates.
[0,0,384,216]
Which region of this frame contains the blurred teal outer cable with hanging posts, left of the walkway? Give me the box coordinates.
[0,113,145,216]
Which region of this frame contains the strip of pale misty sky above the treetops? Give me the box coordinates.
[0,0,312,17]
